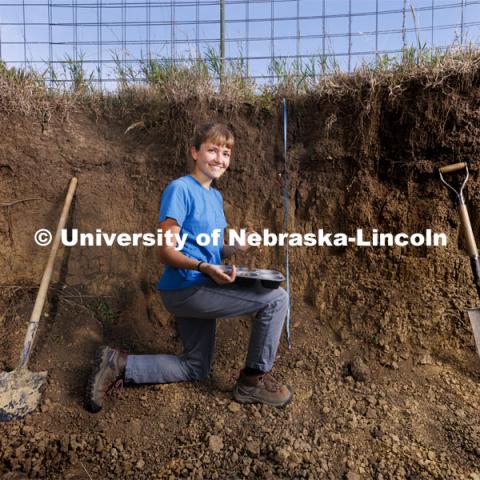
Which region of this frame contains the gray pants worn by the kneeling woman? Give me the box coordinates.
[125,284,288,383]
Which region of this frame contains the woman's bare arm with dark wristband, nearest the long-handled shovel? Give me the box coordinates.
[158,218,237,284]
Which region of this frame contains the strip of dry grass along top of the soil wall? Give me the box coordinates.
[0,43,480,127]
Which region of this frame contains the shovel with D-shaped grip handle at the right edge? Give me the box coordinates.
[439,162,480,355]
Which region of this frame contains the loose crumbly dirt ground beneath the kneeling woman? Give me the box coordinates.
[0,289,480,479]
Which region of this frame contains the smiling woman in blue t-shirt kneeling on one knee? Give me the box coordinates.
[86,123,292,412]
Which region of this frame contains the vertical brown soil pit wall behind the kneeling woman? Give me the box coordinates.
[0,71,480,364]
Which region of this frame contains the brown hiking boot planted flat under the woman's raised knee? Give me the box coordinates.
[233,370,293,407]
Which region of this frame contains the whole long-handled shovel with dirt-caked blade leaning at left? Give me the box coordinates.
[0,177,77,422]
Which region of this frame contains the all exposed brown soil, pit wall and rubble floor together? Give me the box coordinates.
[0,62,480,480]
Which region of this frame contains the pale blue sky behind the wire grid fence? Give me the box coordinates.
[0,0,480,82]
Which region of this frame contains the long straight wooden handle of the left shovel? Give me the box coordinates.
[18,177,77,368]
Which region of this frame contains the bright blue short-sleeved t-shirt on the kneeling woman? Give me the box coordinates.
[157,175,227,290]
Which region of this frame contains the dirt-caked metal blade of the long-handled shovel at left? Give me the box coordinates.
[0,368,47,422]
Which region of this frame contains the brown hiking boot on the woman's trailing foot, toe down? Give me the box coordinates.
[85,346,128,413]
